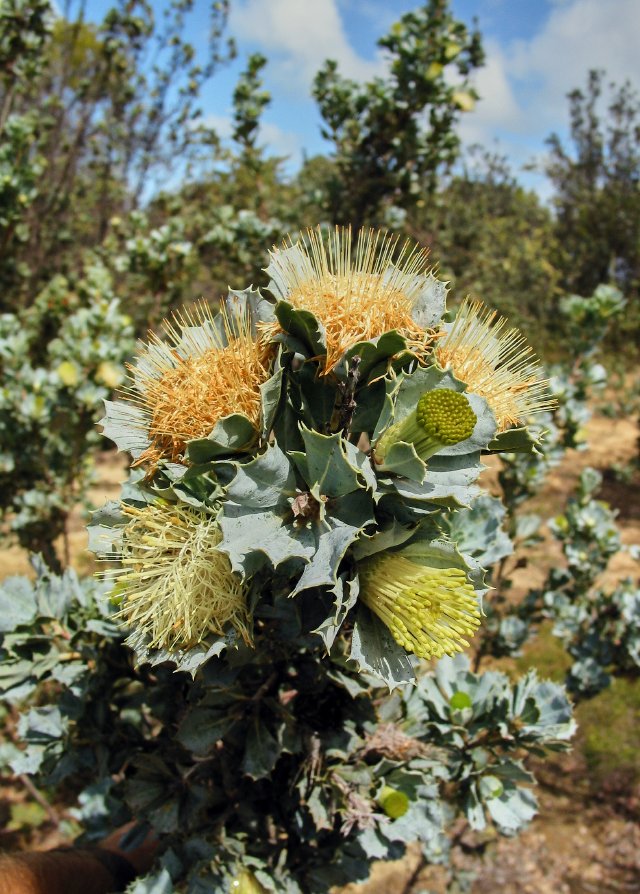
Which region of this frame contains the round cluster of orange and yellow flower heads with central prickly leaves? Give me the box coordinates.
[97,228,548,683]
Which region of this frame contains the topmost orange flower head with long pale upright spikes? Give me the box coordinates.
[268,227,436,374]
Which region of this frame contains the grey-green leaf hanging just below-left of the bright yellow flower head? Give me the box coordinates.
[349,605,415,689]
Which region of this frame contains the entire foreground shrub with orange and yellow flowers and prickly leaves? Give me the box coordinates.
[0,230,573,894]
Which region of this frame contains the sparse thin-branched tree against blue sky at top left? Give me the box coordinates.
[0,0,234,307]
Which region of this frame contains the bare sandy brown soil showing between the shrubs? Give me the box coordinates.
[0,416,640,894]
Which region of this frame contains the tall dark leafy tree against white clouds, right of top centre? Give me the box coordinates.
[313,0,484,229]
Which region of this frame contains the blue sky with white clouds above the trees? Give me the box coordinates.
[88,0,640,195]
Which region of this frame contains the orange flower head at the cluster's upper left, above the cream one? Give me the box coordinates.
[126,303,269,464]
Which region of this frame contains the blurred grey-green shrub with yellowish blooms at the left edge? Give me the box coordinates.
[0,259,134,567]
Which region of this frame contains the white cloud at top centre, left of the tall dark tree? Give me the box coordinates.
[230,0,382,96]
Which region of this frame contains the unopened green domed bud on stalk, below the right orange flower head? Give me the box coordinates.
[373,388,476,465]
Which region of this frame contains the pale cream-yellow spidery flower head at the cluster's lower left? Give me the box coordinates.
[113,505,251,649]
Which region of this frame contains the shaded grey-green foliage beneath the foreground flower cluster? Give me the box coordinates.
[0,566,573,894]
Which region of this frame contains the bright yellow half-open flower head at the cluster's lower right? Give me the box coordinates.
[359,553,480,658]
